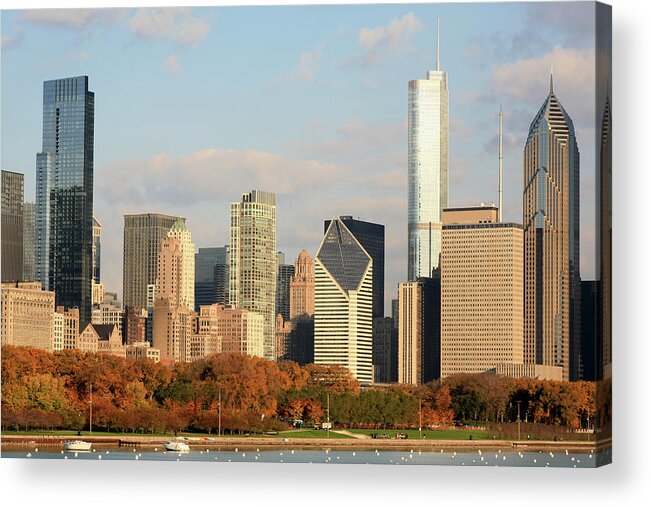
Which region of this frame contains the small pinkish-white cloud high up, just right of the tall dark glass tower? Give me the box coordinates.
[128,7,210,46]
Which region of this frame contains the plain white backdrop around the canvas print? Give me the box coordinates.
[0,0,651,507]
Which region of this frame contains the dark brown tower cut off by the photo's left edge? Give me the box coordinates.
[2,170,25,282]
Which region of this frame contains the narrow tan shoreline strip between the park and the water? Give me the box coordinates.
[0,435,612,452]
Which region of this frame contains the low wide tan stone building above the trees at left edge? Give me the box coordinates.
[2,282,55,352]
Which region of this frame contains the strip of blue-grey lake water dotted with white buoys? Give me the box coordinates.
[2,445,611,468]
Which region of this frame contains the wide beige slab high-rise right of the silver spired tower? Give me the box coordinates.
[438,207,524,378]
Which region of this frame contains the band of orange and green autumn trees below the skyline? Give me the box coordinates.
[2,345,610,434]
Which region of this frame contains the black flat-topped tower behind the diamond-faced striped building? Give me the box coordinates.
[323,216,384,318]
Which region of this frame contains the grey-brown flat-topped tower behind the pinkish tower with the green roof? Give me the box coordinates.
[122,213,185,308]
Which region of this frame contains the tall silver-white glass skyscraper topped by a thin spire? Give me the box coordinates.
[407,20,448,281]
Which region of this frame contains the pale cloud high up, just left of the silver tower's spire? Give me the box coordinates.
[348,12,423,67]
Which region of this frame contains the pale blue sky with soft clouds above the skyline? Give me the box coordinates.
[0,2,602,314]
